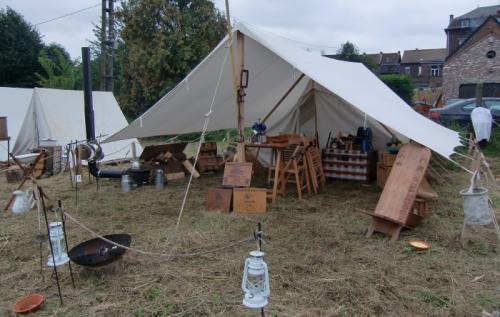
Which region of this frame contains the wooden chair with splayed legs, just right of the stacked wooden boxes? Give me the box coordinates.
[273,145,311,199]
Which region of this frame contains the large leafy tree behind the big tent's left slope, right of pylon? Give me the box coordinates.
[117,0,225,117]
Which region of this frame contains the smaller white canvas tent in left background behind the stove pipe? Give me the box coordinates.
[0,88,142,162]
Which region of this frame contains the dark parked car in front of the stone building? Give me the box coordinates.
[429,97,500,124]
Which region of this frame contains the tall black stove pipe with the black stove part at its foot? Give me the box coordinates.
[82,47,127,178]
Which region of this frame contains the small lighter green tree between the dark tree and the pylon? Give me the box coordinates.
[35,43,82,89]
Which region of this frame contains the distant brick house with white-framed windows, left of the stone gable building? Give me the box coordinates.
[400,48,446,88]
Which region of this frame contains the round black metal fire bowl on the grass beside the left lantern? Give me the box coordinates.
[68,234,132,267]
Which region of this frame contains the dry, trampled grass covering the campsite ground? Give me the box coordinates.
[0,158,500,316]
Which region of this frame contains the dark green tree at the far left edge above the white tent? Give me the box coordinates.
[0,7,43,87]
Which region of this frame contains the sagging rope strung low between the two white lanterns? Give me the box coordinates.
[64,212,255,259]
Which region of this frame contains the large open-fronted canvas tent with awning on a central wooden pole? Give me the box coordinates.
[105,23,461,157]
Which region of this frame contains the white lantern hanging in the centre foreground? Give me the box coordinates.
[241,250,271,309]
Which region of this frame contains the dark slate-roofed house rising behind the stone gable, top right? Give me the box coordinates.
[444,5,500,56]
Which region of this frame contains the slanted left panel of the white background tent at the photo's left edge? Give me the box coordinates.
[0,87,33,161]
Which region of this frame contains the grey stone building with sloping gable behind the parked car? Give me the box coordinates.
[443,15,500,102]
